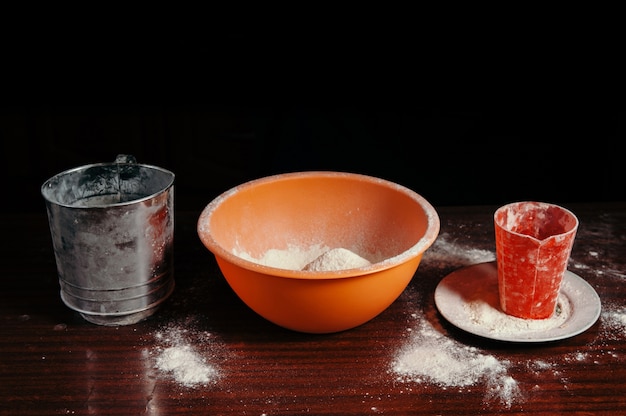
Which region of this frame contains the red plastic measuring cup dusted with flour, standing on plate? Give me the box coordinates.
[494,202,578,319]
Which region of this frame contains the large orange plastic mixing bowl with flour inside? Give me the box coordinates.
[197,172,439,333]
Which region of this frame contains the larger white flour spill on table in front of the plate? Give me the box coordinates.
[391,321,521,407]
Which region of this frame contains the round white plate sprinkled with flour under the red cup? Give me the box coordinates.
[435,261,601,342]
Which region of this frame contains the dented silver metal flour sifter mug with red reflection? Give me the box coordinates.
[41,155,174,325]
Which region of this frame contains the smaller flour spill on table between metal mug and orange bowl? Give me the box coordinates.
[155,325,220,388]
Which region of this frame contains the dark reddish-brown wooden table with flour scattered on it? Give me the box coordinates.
[0,203,626,416]
